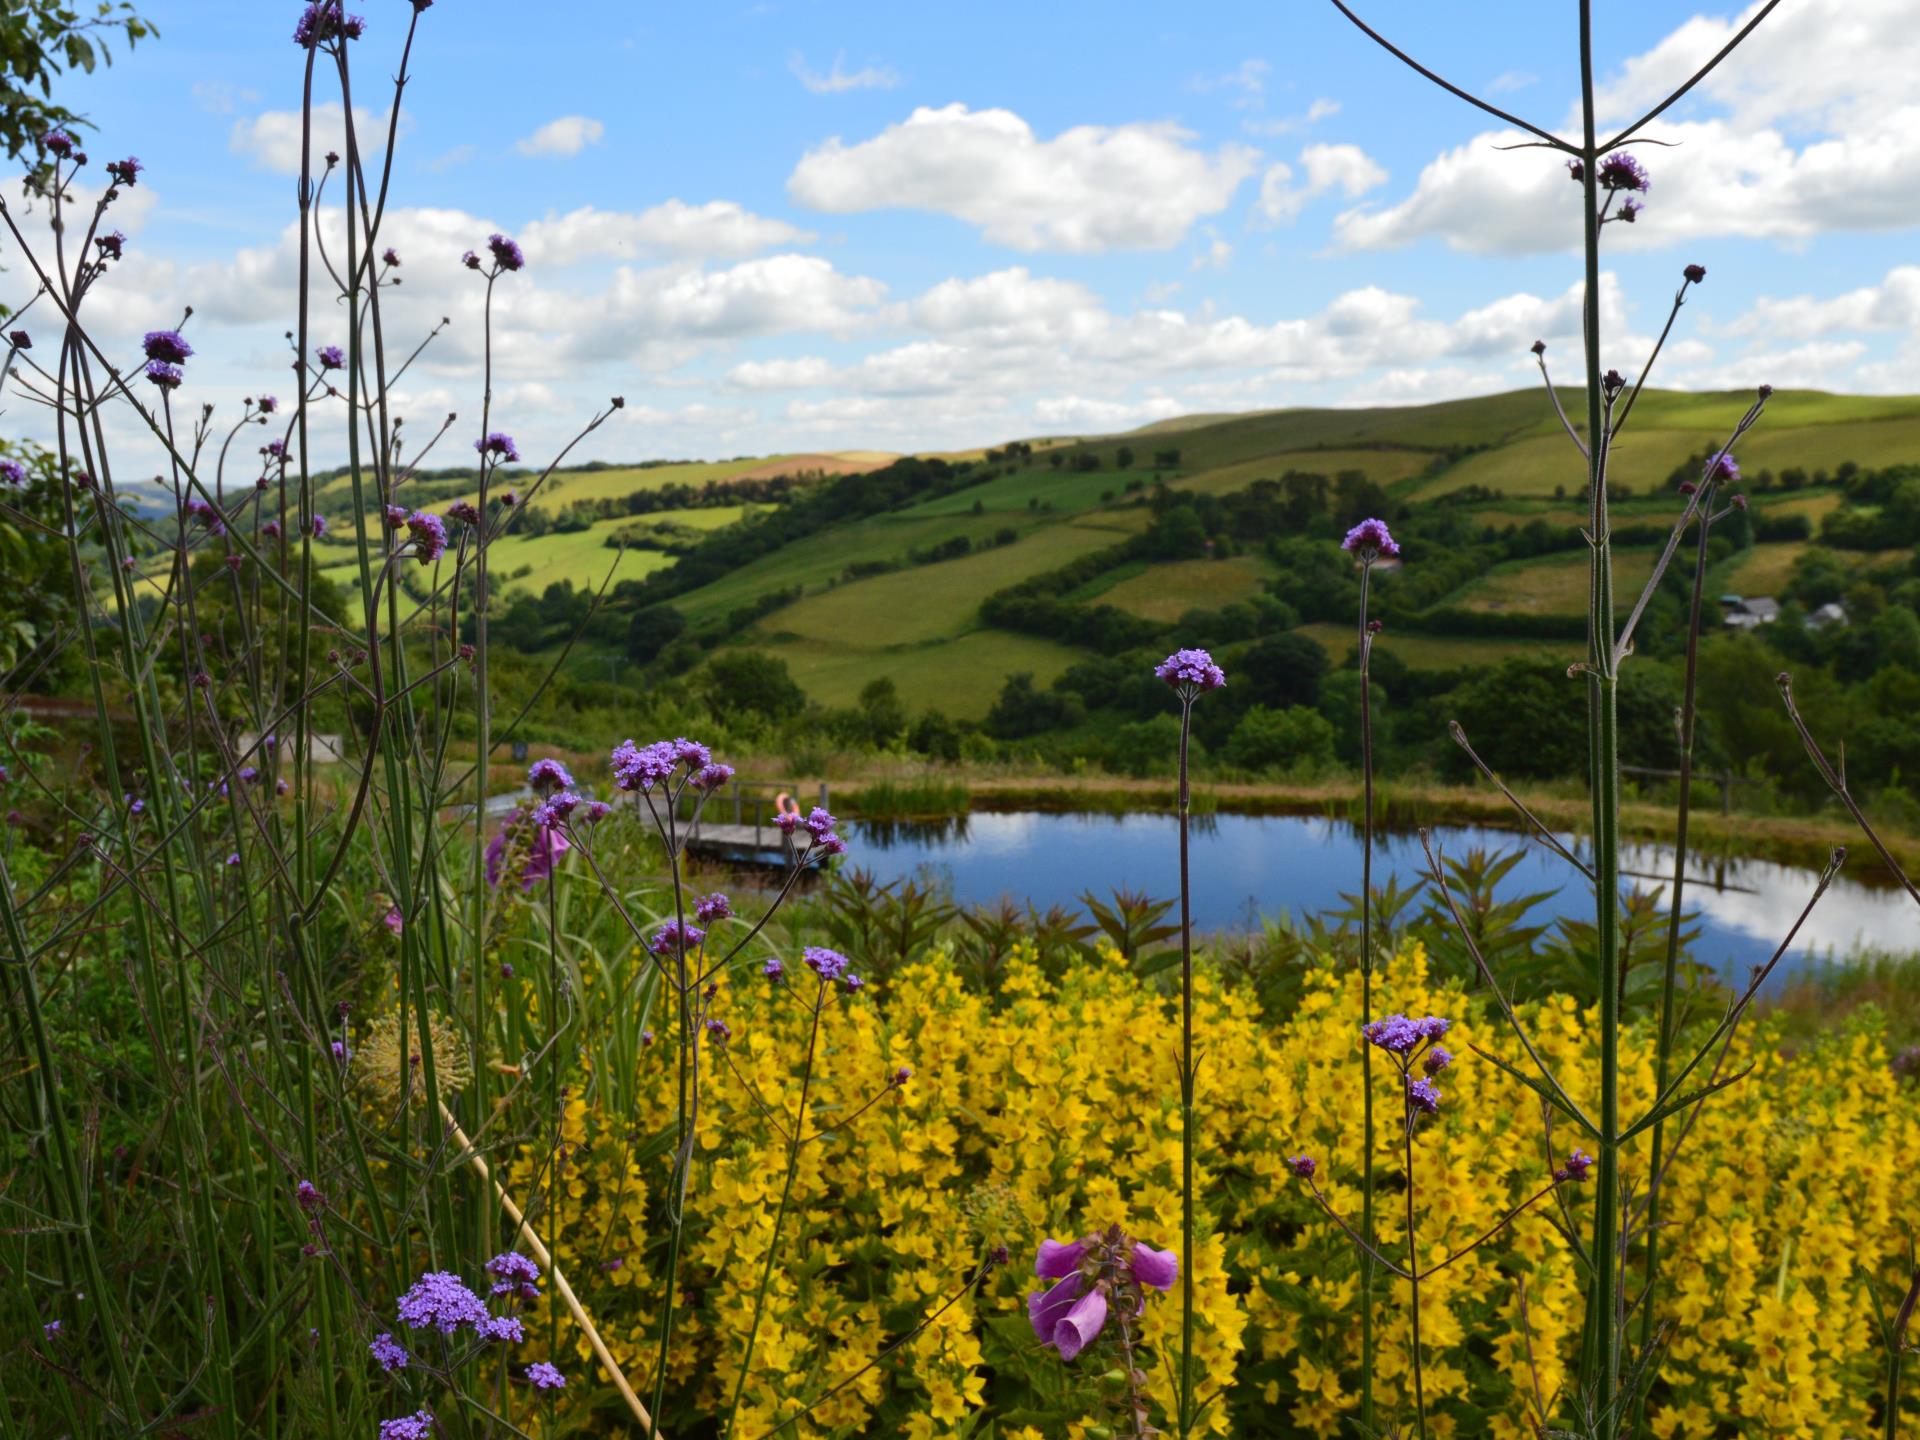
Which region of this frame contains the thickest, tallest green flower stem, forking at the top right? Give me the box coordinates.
[1580,0,1620,1427]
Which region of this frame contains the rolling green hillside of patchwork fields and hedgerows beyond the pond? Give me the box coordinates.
[311,392,1920,718]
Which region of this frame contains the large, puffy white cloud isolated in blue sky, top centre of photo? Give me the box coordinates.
[787,104,1258,253]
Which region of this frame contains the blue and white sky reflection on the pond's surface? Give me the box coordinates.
[852,812,1920,975]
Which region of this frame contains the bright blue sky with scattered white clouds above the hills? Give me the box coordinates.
[15,0,1920,459]
